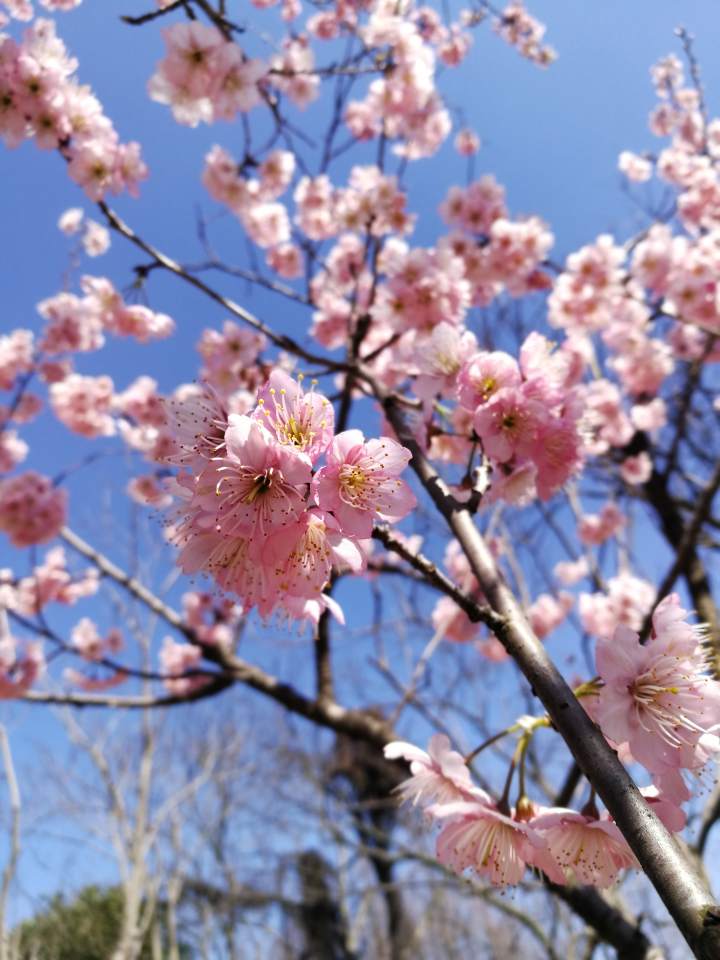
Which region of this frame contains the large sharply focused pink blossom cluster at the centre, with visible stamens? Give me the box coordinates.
[162,369,415,621]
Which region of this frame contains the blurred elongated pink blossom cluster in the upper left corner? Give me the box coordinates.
[0,19,147,200]
